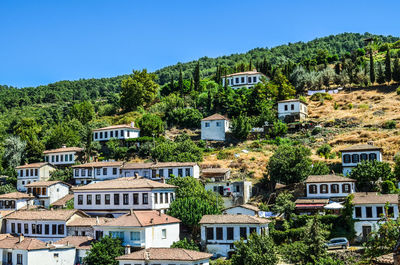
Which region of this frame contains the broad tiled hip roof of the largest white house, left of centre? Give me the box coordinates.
[72,177,175,191]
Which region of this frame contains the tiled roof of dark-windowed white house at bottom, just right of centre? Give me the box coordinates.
[199,214,270,224]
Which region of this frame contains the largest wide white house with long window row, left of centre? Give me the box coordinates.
[73,177,175,217]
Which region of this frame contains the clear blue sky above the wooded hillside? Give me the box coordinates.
[0,0,400,87]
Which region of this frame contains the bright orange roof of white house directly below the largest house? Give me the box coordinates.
[99,210,181,227]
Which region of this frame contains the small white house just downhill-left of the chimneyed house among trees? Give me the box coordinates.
[43,145,83,166]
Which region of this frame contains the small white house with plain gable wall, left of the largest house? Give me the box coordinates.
[25,180,71,208]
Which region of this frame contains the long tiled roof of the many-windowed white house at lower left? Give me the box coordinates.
[4,210,88,221]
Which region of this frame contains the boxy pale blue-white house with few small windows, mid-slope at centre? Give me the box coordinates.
[201,113,230,141]
